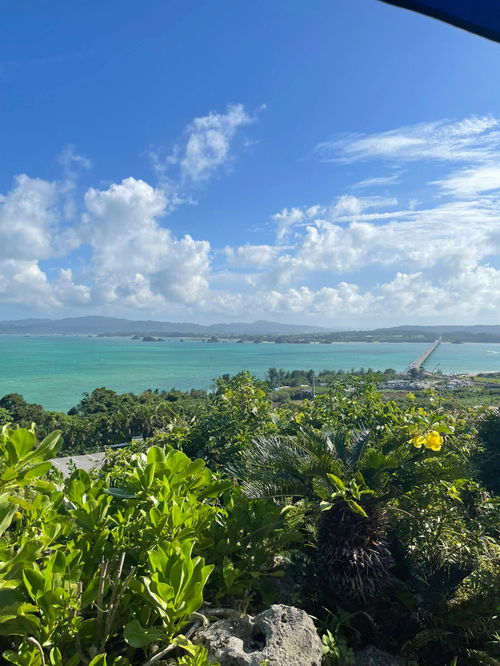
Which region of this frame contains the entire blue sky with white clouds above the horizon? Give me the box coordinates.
[0,0,500,328]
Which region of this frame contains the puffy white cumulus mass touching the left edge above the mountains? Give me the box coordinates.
[0,171,210,308]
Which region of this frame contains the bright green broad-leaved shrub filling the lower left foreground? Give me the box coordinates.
[0,428,286,666]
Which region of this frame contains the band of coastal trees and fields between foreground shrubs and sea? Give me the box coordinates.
[0,368,500,457]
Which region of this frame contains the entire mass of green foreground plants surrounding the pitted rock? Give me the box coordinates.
[0,370,500,666]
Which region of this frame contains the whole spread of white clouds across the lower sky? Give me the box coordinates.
[0,111,500,326]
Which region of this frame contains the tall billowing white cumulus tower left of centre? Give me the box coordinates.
[84,178,210,307]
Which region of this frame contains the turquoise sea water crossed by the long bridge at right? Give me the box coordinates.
[0,335,500,411]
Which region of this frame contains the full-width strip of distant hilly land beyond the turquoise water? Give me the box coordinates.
[0,316,500,344]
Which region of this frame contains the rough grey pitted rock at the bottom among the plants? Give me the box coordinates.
[196,604,323,666]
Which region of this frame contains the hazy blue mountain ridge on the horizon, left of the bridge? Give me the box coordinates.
[0,316,331,336]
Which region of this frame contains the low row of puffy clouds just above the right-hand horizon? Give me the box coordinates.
[209,258,500,326]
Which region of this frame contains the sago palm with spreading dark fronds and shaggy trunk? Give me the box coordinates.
[230,430,468,607]
